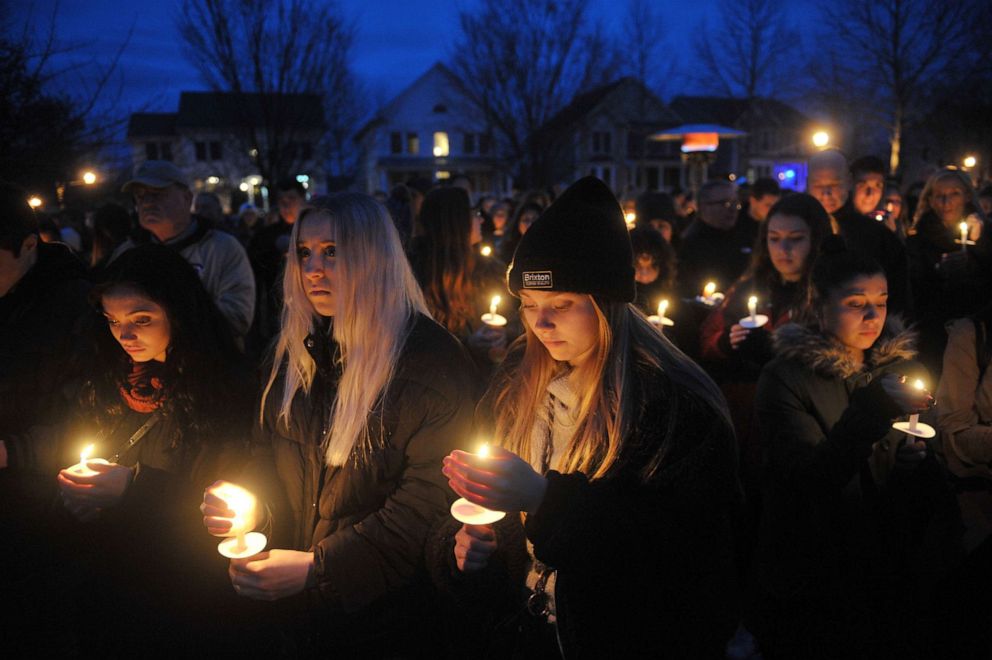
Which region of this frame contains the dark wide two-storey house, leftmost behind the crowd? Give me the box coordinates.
[127,92,326,211]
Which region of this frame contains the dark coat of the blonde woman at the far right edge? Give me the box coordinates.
[906,212,992,374]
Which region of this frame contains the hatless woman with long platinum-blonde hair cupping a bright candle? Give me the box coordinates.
[203,194,476,657]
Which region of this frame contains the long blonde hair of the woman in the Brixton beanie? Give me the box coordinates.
[495,298,730,480]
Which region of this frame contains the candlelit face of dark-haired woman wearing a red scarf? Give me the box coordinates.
[100,286,171,362]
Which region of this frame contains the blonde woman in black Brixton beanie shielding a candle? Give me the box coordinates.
[429,177,739,658]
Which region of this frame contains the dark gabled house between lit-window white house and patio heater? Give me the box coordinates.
[538,77,682,194]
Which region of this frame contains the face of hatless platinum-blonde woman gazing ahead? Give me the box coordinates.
[296,213,337,316]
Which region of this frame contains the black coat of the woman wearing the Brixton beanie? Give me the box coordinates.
[428,356,740,658]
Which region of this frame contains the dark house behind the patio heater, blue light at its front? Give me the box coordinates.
[671,96,813,190]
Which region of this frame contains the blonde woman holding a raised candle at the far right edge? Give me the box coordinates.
[906,169,992,375]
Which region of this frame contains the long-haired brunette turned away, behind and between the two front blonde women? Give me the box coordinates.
[411,187,513,374]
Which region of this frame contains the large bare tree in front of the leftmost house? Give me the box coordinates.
[176,0,357,183]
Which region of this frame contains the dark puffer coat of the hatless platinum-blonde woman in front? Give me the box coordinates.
[242,316,477,657]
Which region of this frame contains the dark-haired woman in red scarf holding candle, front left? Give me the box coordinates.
[58,245,252,653]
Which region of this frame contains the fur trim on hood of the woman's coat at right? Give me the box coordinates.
[775,316,917,379]
